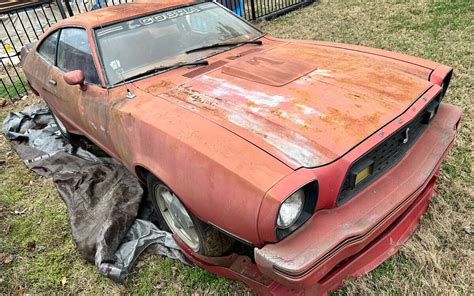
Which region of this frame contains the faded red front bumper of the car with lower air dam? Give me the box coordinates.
[255,104,462,291]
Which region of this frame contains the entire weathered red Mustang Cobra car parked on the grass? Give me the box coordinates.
[22,2,462,292]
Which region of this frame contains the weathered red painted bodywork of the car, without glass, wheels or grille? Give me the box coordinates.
[22,2,461,293]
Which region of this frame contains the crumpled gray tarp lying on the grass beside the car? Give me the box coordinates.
[3,105,191,281]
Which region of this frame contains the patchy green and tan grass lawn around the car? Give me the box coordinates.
[0,0,474,295]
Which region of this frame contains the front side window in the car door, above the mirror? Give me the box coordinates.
[57,28,100,84]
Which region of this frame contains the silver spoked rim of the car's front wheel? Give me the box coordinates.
[155,185,199,252]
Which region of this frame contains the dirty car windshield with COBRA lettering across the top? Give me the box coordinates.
[96,3,261,85]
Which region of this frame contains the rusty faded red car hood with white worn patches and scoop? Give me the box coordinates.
[136,42,432,168]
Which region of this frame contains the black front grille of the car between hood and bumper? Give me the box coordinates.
[337,95,441,204]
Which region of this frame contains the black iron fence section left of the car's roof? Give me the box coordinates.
[0,0,133,100]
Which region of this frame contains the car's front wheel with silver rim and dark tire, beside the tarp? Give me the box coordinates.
[147,174,234,257]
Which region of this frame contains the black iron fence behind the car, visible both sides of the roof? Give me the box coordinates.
[0,0,314,100]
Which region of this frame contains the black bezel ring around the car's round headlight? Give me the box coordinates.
[274,180,319,240]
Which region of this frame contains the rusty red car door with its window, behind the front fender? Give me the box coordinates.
[56,28,115,154]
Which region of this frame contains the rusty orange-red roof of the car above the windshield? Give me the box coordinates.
[58,0,196,28]
